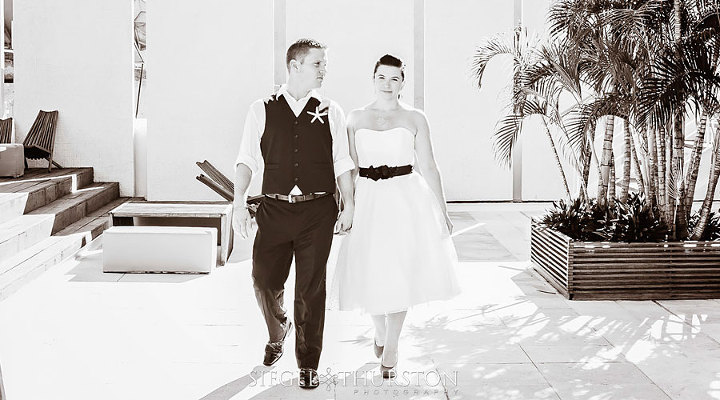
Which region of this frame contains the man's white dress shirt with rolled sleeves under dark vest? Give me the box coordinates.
[235,85,355,194]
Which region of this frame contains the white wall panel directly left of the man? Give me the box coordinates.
[146,0,273,201]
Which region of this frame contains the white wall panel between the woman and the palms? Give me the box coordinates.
[425,0,513,200]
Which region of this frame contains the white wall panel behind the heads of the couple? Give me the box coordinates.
[286,0,415,114]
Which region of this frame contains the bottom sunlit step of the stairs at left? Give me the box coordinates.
[0,233,87,300]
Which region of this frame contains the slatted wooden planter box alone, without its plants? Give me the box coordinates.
[530,221,720,300]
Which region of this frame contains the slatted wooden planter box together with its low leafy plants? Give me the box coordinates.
[530,193,720,300]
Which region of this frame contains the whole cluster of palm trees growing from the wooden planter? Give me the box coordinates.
[474,0,720,240]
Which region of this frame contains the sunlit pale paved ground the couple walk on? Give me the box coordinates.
[0,204,720,400]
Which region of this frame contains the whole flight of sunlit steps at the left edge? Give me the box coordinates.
[0,168,128,298]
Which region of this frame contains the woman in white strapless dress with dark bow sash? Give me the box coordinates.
[335,55,459,378]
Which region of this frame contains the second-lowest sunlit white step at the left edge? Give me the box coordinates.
[0,215,54,262]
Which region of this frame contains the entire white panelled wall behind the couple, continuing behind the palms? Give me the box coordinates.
[145,0,720,201]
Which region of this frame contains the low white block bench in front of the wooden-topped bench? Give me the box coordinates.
[102,226,217,273]
